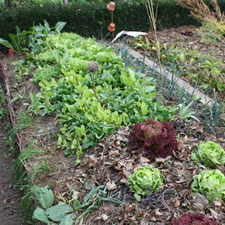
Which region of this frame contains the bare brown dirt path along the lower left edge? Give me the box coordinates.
[0,125,24,225]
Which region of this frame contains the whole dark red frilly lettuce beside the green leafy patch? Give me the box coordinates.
[128,119,178,159]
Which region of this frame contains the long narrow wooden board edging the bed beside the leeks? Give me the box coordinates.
[115,44,215,106]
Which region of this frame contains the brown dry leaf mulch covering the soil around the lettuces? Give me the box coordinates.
[1,46,225,225]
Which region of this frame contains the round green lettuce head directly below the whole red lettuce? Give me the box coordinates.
[128,165,164,201]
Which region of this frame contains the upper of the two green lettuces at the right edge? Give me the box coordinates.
[191,141,225,168]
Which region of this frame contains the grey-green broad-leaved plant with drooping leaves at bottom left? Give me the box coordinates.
[33,185,122,225]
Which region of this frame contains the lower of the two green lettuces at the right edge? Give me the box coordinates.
[191,169,225,202]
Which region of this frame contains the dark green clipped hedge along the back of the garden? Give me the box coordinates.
[0,1,202,51]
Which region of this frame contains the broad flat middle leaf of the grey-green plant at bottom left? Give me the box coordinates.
[46,202,73,222]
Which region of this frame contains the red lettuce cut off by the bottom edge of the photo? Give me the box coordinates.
[171,213,218,225]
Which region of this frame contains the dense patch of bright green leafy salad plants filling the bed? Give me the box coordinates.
[25,33,173,163]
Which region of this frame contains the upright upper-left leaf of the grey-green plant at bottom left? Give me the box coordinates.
[35,186,54,209]
